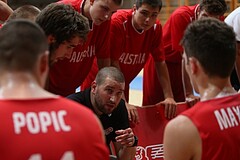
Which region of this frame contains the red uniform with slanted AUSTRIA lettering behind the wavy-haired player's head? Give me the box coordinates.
[48,0,110,96]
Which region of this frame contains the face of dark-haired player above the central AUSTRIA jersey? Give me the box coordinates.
[133,3,159,30]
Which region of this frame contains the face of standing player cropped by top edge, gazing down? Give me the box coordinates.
[90,0,120,25]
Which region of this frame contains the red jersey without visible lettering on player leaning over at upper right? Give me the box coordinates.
[163,5,199,63]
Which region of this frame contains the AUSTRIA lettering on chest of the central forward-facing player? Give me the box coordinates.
[119,53,146,64]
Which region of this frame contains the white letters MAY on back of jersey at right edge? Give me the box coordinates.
[214,106,240,130]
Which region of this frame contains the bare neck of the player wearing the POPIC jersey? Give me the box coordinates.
[0,73,55,99]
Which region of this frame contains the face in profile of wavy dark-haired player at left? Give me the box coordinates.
[51,37,84,63]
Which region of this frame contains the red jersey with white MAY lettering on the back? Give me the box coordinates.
[182,94,240,160]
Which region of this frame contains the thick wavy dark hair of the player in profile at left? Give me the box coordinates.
[36,3,89,46]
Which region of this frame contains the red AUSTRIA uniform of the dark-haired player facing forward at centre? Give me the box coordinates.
[82,9,165,100]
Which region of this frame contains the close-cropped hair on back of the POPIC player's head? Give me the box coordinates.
[0,19,48,72]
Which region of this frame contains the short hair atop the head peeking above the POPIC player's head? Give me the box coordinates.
[7,5,40,21]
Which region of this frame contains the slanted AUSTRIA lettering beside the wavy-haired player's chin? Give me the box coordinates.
[69,45,95,63]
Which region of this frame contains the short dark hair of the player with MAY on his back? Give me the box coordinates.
[182,18,236,78]
